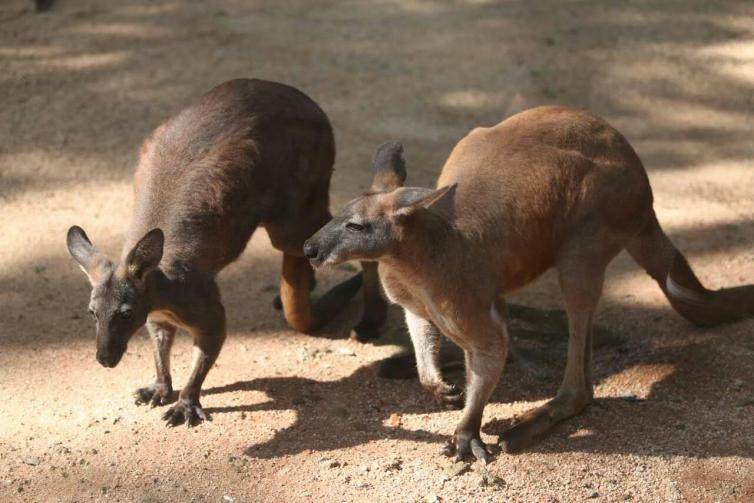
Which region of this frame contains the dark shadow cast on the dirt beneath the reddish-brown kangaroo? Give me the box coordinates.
[204,292,754,458]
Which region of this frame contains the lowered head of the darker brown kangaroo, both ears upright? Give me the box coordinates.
[67,226,164,367]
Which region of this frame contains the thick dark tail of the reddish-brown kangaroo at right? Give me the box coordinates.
[626,213,754,327]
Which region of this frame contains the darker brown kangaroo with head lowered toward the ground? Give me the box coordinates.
[67,79,386,426]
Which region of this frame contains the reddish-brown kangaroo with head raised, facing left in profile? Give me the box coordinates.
[304,107,754,462]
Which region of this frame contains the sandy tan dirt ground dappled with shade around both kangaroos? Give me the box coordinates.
[0,0,754,503]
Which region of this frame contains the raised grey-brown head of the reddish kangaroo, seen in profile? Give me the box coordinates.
[304,142,455,267]
